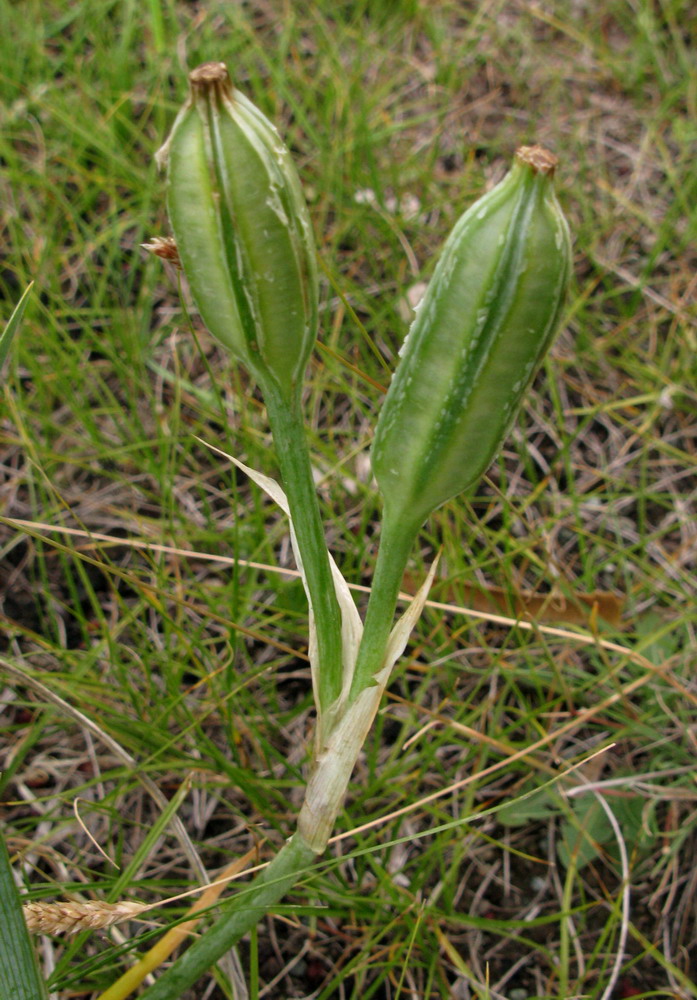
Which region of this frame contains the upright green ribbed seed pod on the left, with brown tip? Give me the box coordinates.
[158,62,318,398]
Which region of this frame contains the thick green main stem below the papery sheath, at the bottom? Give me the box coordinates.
[141,833,316,1000]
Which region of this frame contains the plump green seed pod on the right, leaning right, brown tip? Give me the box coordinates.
[372,146,571,529]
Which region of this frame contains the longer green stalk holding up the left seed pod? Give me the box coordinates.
[263,385,342,711]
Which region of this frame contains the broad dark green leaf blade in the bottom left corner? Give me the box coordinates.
[0,832,48,1000]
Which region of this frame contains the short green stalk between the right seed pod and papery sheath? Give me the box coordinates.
[349,510,421,702]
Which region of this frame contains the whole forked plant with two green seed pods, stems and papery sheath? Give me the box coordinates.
[143,63,571,1000]
